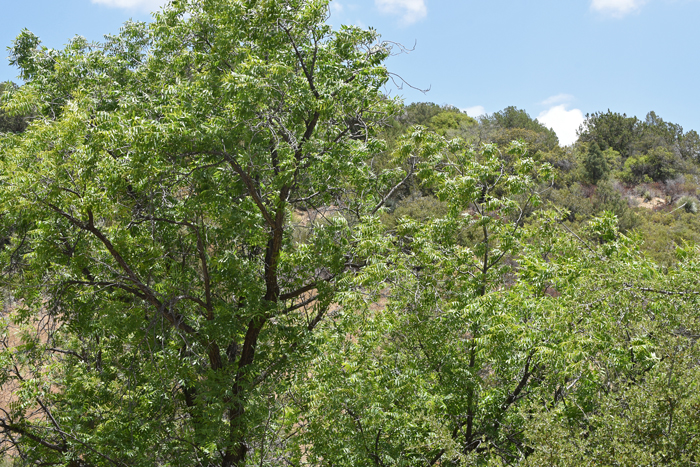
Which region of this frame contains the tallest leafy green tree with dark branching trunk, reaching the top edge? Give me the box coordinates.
[0,0,412,467]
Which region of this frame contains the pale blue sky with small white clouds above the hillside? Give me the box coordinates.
[0,0,700,143]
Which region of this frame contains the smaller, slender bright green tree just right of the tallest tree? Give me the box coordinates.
[295,141,568,466]
